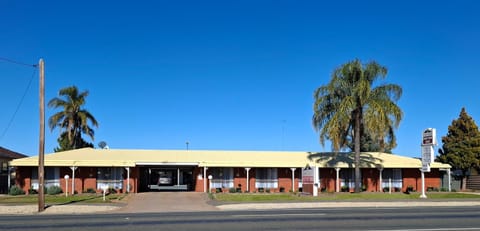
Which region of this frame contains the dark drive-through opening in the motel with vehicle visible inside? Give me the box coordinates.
[140,166,194,192]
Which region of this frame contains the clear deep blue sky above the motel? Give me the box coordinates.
[0,1,480,157]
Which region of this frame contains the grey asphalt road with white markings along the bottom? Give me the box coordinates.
[0,207,480,231]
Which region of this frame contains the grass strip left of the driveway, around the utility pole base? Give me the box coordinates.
[0,194,126,204]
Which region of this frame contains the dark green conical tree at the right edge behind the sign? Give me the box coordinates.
[437,108,480,190]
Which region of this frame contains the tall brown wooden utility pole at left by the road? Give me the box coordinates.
[38,59,45,212]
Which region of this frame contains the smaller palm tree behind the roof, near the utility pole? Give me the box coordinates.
[48,86,98,149]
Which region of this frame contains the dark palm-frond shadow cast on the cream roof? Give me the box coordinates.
[308,152,383,168]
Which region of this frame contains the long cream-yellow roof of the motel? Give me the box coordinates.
[10,148,450,168]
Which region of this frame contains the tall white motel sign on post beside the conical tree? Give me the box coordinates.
[420,128,437,198]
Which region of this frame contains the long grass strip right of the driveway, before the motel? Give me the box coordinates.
[211,192,480,202]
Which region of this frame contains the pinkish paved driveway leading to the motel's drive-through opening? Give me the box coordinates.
[116,192,218,213]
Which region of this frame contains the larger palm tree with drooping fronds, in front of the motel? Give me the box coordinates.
[312,59,403,192]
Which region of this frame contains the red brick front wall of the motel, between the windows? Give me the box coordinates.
[15,167,441,193]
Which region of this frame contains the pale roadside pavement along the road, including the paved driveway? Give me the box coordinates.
[0,193,480,215]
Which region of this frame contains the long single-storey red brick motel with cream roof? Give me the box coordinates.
[6,148,451,195]
